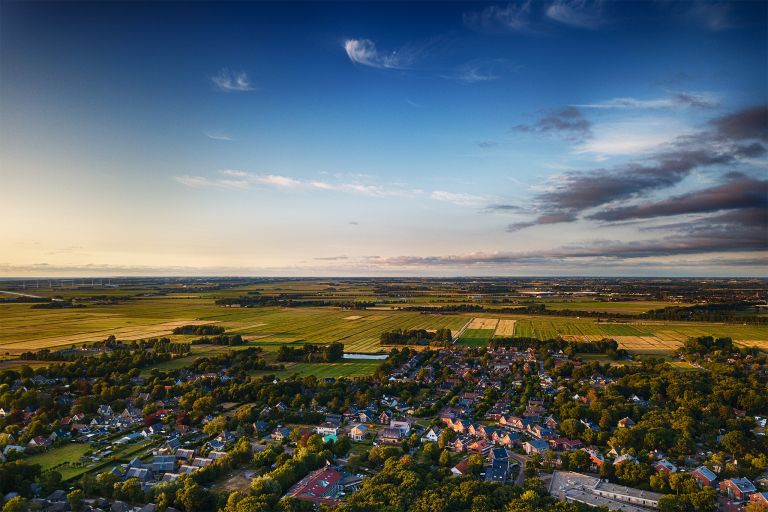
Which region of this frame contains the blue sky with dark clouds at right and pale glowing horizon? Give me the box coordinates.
[0,0,768,277]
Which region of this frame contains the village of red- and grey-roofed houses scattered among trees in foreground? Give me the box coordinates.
[0,330,768,512]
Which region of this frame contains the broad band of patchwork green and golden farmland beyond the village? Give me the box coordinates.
[0,281,768,366]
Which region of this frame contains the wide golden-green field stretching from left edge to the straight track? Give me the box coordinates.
[0,297,466,354]
